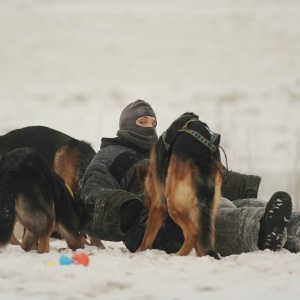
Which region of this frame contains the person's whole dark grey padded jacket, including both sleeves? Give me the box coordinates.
[80,138,260,253]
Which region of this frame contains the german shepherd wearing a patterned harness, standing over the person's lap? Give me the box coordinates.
[137,113,222,259]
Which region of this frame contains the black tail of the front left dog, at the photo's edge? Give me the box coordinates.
[0,182,16,248]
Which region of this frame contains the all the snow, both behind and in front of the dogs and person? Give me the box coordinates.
[0,0,300,299]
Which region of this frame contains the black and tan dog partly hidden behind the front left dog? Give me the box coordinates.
[0,126,96,193]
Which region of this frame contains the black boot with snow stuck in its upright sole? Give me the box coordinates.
[258,192,292,251]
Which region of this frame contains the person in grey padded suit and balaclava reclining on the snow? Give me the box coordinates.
[77,100,300,256]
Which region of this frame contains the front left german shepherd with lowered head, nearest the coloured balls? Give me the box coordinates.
[0,148,86,253]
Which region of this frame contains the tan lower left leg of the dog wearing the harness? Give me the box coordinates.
[136,203,167,252]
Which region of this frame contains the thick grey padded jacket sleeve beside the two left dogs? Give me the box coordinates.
[80,148,141,241]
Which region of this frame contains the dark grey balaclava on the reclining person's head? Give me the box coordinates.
[117,100,158,150]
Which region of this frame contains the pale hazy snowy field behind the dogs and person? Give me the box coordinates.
[0,0,300,210]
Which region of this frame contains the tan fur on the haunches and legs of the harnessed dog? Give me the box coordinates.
[137,139,222,256]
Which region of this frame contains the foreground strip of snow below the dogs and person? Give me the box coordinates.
[0,241,300,300]
